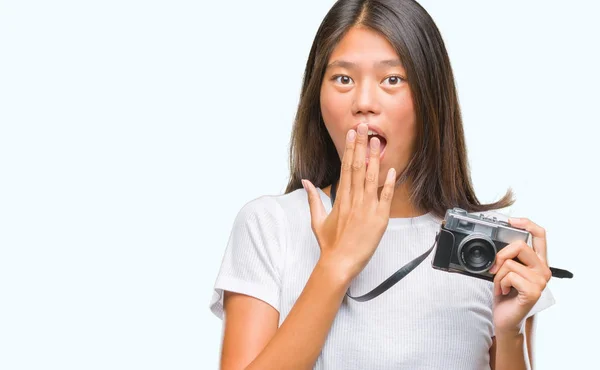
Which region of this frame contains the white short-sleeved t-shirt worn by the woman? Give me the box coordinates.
[210,189,554,370]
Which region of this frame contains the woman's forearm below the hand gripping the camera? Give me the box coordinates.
[495,333,530,370]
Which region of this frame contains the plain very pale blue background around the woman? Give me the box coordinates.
[0,0,600,370]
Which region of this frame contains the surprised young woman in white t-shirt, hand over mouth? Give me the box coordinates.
[211,0,554,370]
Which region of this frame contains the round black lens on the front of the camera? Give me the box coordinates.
[458,234,496,273]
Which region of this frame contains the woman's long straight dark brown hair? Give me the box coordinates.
[285,0,514,217]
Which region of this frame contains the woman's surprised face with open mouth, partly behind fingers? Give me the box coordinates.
[321,27,416,186]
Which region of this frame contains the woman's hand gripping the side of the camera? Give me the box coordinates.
[490,218,552,335]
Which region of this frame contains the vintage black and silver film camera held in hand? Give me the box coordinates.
[432,208,529,281]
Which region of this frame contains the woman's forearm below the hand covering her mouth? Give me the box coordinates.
[246,260,350,370]
